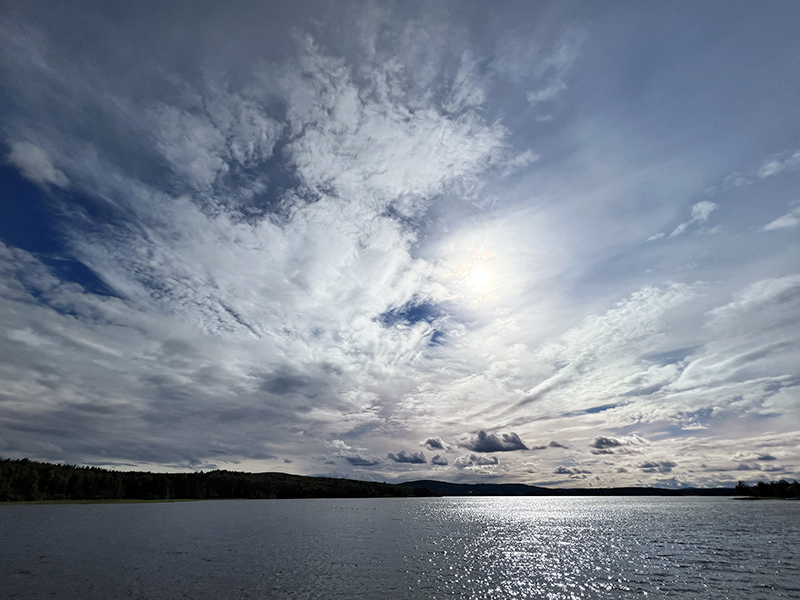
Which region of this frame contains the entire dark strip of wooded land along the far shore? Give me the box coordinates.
[0,459,744,502]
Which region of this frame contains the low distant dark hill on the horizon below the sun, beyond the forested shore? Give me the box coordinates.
[403,479,736,496]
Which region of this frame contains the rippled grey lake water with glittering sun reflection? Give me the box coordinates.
[0,497,800,600]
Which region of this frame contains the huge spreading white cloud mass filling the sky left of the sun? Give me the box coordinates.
[3,10,507,468]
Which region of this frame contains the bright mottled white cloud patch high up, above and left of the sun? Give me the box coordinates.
[283,42,506,216]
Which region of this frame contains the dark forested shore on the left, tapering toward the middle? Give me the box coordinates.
[0,458,431,502]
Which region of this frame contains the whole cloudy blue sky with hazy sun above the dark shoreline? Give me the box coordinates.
[0,0,800,487]
